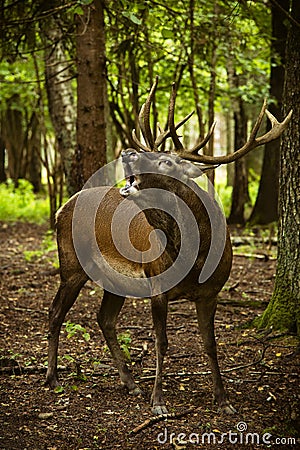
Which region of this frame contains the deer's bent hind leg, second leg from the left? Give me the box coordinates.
[97,291,142,395]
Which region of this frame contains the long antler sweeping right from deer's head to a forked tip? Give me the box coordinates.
[179,100,292,164]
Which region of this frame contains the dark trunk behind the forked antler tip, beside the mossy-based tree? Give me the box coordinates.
[249,0,290,225]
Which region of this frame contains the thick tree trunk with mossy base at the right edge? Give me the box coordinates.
[259,0,300,335]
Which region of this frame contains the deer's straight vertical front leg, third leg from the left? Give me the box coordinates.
[151,295,168,415]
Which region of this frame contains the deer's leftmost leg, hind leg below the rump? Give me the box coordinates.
[46,273,88,388]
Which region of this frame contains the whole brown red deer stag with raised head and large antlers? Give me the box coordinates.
[47,76,291,414]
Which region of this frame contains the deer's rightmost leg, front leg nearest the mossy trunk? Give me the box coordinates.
[196,298,236,414]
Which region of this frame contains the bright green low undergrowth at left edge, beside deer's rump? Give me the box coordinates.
[0,180,49,224]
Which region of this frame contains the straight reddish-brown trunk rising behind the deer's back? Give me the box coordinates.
[72,0,106,190]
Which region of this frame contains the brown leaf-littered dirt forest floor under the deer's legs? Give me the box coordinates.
[0,223,300,450]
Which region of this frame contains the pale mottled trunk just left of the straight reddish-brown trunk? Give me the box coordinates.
[41,6,76,195]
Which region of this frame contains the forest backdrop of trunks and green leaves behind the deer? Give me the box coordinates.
[0,0,289,224]
